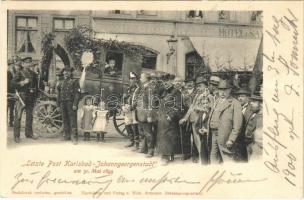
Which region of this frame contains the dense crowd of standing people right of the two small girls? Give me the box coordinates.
[123,72,262,165]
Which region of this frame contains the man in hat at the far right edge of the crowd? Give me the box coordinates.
[245,92,263,160]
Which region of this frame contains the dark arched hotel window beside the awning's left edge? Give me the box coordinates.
[186,51,203,80]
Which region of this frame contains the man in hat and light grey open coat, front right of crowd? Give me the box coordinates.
[208,80,243,164]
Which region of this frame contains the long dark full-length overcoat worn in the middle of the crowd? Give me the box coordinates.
[157,88,184,155]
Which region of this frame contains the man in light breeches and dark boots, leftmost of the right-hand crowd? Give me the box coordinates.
[123,72,139,150]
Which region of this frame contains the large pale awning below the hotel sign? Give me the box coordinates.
[190,37,260,71]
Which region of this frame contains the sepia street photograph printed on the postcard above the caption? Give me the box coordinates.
[7,10,263,165]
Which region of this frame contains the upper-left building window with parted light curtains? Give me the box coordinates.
[16,17,39,53]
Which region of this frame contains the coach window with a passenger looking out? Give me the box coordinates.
[104,51,123,76]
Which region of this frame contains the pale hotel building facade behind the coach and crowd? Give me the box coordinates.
[8,10,262,79]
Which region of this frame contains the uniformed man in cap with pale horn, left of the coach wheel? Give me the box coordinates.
[12,57,38,143]
